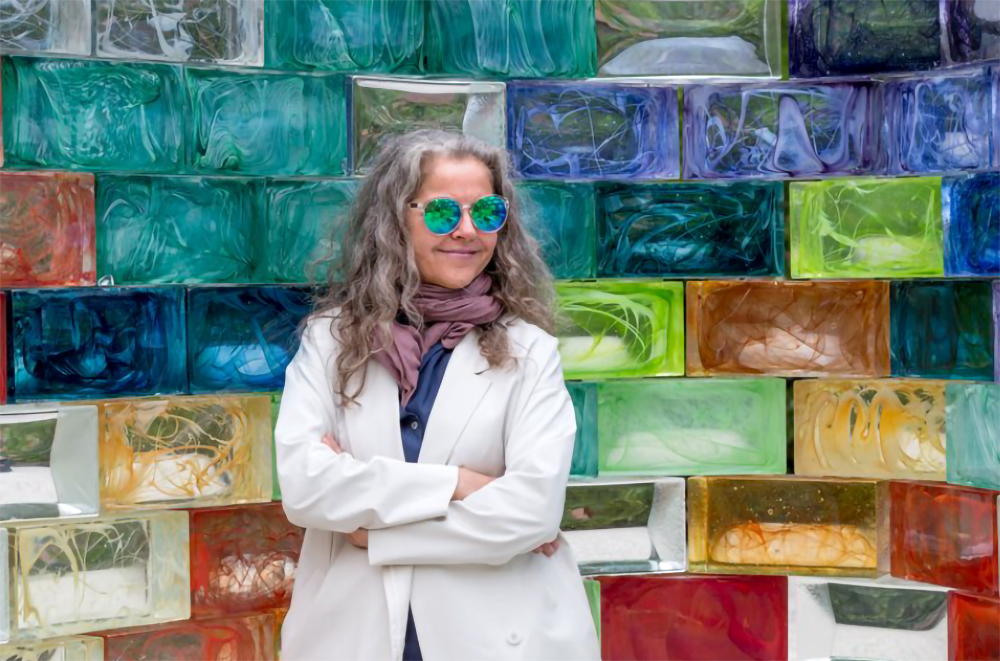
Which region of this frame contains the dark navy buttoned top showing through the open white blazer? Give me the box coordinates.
[399,342,451,661]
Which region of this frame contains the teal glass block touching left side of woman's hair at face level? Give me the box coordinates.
[254,179,361,283]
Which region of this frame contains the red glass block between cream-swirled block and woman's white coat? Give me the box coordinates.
[191,503,305,618]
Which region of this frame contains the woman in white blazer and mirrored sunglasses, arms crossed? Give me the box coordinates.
[275,131,600,661]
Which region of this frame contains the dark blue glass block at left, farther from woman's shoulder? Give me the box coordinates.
[8,287,187,402]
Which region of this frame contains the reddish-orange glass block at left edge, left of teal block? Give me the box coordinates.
[0,172,96,287]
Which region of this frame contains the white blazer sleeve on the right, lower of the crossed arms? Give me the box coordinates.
[368,336,576,565]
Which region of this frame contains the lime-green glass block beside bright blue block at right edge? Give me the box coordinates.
[790,177,944,278]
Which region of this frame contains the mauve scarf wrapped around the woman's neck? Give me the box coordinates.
[373,273,502,406]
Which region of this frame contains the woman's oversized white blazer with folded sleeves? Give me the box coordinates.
[275,310,601,661]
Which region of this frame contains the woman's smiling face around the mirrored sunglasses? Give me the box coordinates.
[407,156,503,289]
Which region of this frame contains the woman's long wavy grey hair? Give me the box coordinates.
[316,130,554,403]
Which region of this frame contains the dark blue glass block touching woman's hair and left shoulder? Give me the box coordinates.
[187,287,311,393]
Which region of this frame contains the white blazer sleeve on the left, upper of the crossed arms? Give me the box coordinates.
[275,319,458,533]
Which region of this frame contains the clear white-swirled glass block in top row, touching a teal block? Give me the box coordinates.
[95,0,264,66]
